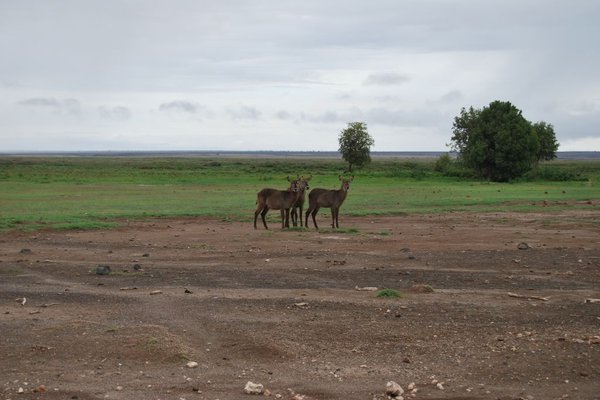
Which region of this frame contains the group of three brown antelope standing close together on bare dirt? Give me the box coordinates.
[254,175,354,229]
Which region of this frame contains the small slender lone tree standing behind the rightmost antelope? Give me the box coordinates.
[338,122,375,172]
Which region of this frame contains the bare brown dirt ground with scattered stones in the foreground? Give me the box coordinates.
[0,211,600,400]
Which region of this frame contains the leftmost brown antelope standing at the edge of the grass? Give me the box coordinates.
[254,176,300,229]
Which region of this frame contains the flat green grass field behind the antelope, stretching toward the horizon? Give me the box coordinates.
[0,157,600,230]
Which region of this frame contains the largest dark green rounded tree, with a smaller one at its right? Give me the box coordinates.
[452,101,540,181]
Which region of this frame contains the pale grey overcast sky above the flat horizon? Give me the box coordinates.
[0,0,600,151]
